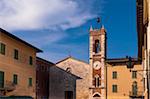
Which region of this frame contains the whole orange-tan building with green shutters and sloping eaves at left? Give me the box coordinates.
[0,29,42,98]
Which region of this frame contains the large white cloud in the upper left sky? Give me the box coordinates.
[0,0,99,30]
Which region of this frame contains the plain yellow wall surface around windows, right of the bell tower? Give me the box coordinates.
[107,64,144,99]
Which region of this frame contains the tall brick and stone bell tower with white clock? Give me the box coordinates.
[89,26,106,99]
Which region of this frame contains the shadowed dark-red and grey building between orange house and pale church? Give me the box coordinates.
[36,57,81,99]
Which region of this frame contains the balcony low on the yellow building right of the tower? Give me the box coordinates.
[129,91,144,99]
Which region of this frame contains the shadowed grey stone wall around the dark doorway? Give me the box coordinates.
[49,66,76,99]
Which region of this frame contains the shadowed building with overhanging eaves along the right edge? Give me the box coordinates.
[136,0,150,99]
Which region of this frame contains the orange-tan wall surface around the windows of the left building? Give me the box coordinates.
[0,33,36,97]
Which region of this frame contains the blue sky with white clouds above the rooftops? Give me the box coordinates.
[0,0,137,62]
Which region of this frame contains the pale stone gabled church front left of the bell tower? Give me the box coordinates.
[56,57,90,99]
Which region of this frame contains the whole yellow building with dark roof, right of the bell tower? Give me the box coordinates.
[106,58,144,99]
